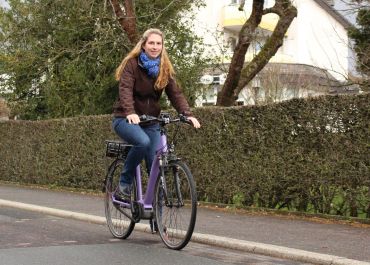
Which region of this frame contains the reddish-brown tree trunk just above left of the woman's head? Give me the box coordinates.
[111,0,139,45]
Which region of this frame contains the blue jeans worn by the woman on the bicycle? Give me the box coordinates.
[112,118,161,184]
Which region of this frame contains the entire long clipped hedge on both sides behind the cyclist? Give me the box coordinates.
[0,94,370,218]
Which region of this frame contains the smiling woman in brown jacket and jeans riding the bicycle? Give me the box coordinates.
[113,29,200,199]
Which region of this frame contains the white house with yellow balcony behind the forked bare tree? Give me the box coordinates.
[195,0,353,105]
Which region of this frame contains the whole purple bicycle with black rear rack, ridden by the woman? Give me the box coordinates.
[104,114,197,250]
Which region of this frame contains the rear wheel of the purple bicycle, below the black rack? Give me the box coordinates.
[105,159,135,239]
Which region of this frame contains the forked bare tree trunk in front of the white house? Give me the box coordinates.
[217,0,297,106]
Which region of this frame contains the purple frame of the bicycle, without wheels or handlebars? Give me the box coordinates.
[111,129,168,211]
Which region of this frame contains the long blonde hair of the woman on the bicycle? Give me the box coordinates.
[115,28,175,90]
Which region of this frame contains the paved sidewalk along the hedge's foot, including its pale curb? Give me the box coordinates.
[0,185,370,264]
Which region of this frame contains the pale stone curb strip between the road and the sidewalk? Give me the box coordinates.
[0,199,370,265]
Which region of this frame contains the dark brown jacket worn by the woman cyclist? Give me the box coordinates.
[113,58,191,117]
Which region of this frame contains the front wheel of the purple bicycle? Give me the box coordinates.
[154,161,197,250]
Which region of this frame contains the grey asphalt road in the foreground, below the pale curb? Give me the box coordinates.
[0,207,308,265]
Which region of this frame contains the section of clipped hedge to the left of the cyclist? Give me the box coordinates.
[0,116,113,189]
